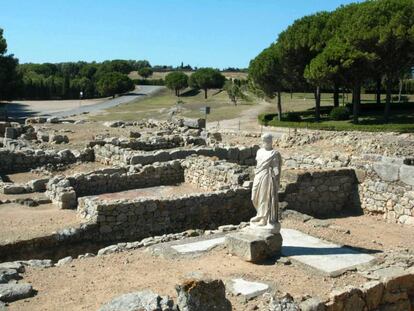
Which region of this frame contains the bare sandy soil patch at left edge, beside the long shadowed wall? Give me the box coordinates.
[0,204,80,244]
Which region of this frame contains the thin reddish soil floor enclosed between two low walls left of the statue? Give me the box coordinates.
[98,183,206,200]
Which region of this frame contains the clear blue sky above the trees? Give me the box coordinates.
[0,0,355,68]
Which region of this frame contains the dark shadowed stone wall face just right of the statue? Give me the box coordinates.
[279,169,359,217]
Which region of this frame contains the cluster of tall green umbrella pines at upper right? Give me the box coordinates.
[249,0,414,123]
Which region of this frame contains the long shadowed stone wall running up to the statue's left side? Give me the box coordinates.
[78,187,255,241]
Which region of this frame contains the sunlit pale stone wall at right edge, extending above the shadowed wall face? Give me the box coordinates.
[283,153,414,225]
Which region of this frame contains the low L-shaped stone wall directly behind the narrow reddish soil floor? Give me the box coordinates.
[46,156,249,208]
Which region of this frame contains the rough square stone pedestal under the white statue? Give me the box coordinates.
[225,227,282,263]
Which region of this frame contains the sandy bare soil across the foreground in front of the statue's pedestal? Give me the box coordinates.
[10,248,364,311]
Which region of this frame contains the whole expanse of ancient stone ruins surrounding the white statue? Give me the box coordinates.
[0,117,414,310]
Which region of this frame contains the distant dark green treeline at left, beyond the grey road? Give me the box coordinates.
[17,60,150,99]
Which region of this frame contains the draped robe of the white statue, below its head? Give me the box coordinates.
[251,149,282,225]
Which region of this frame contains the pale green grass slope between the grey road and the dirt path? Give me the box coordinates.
[90,89,258,121]
